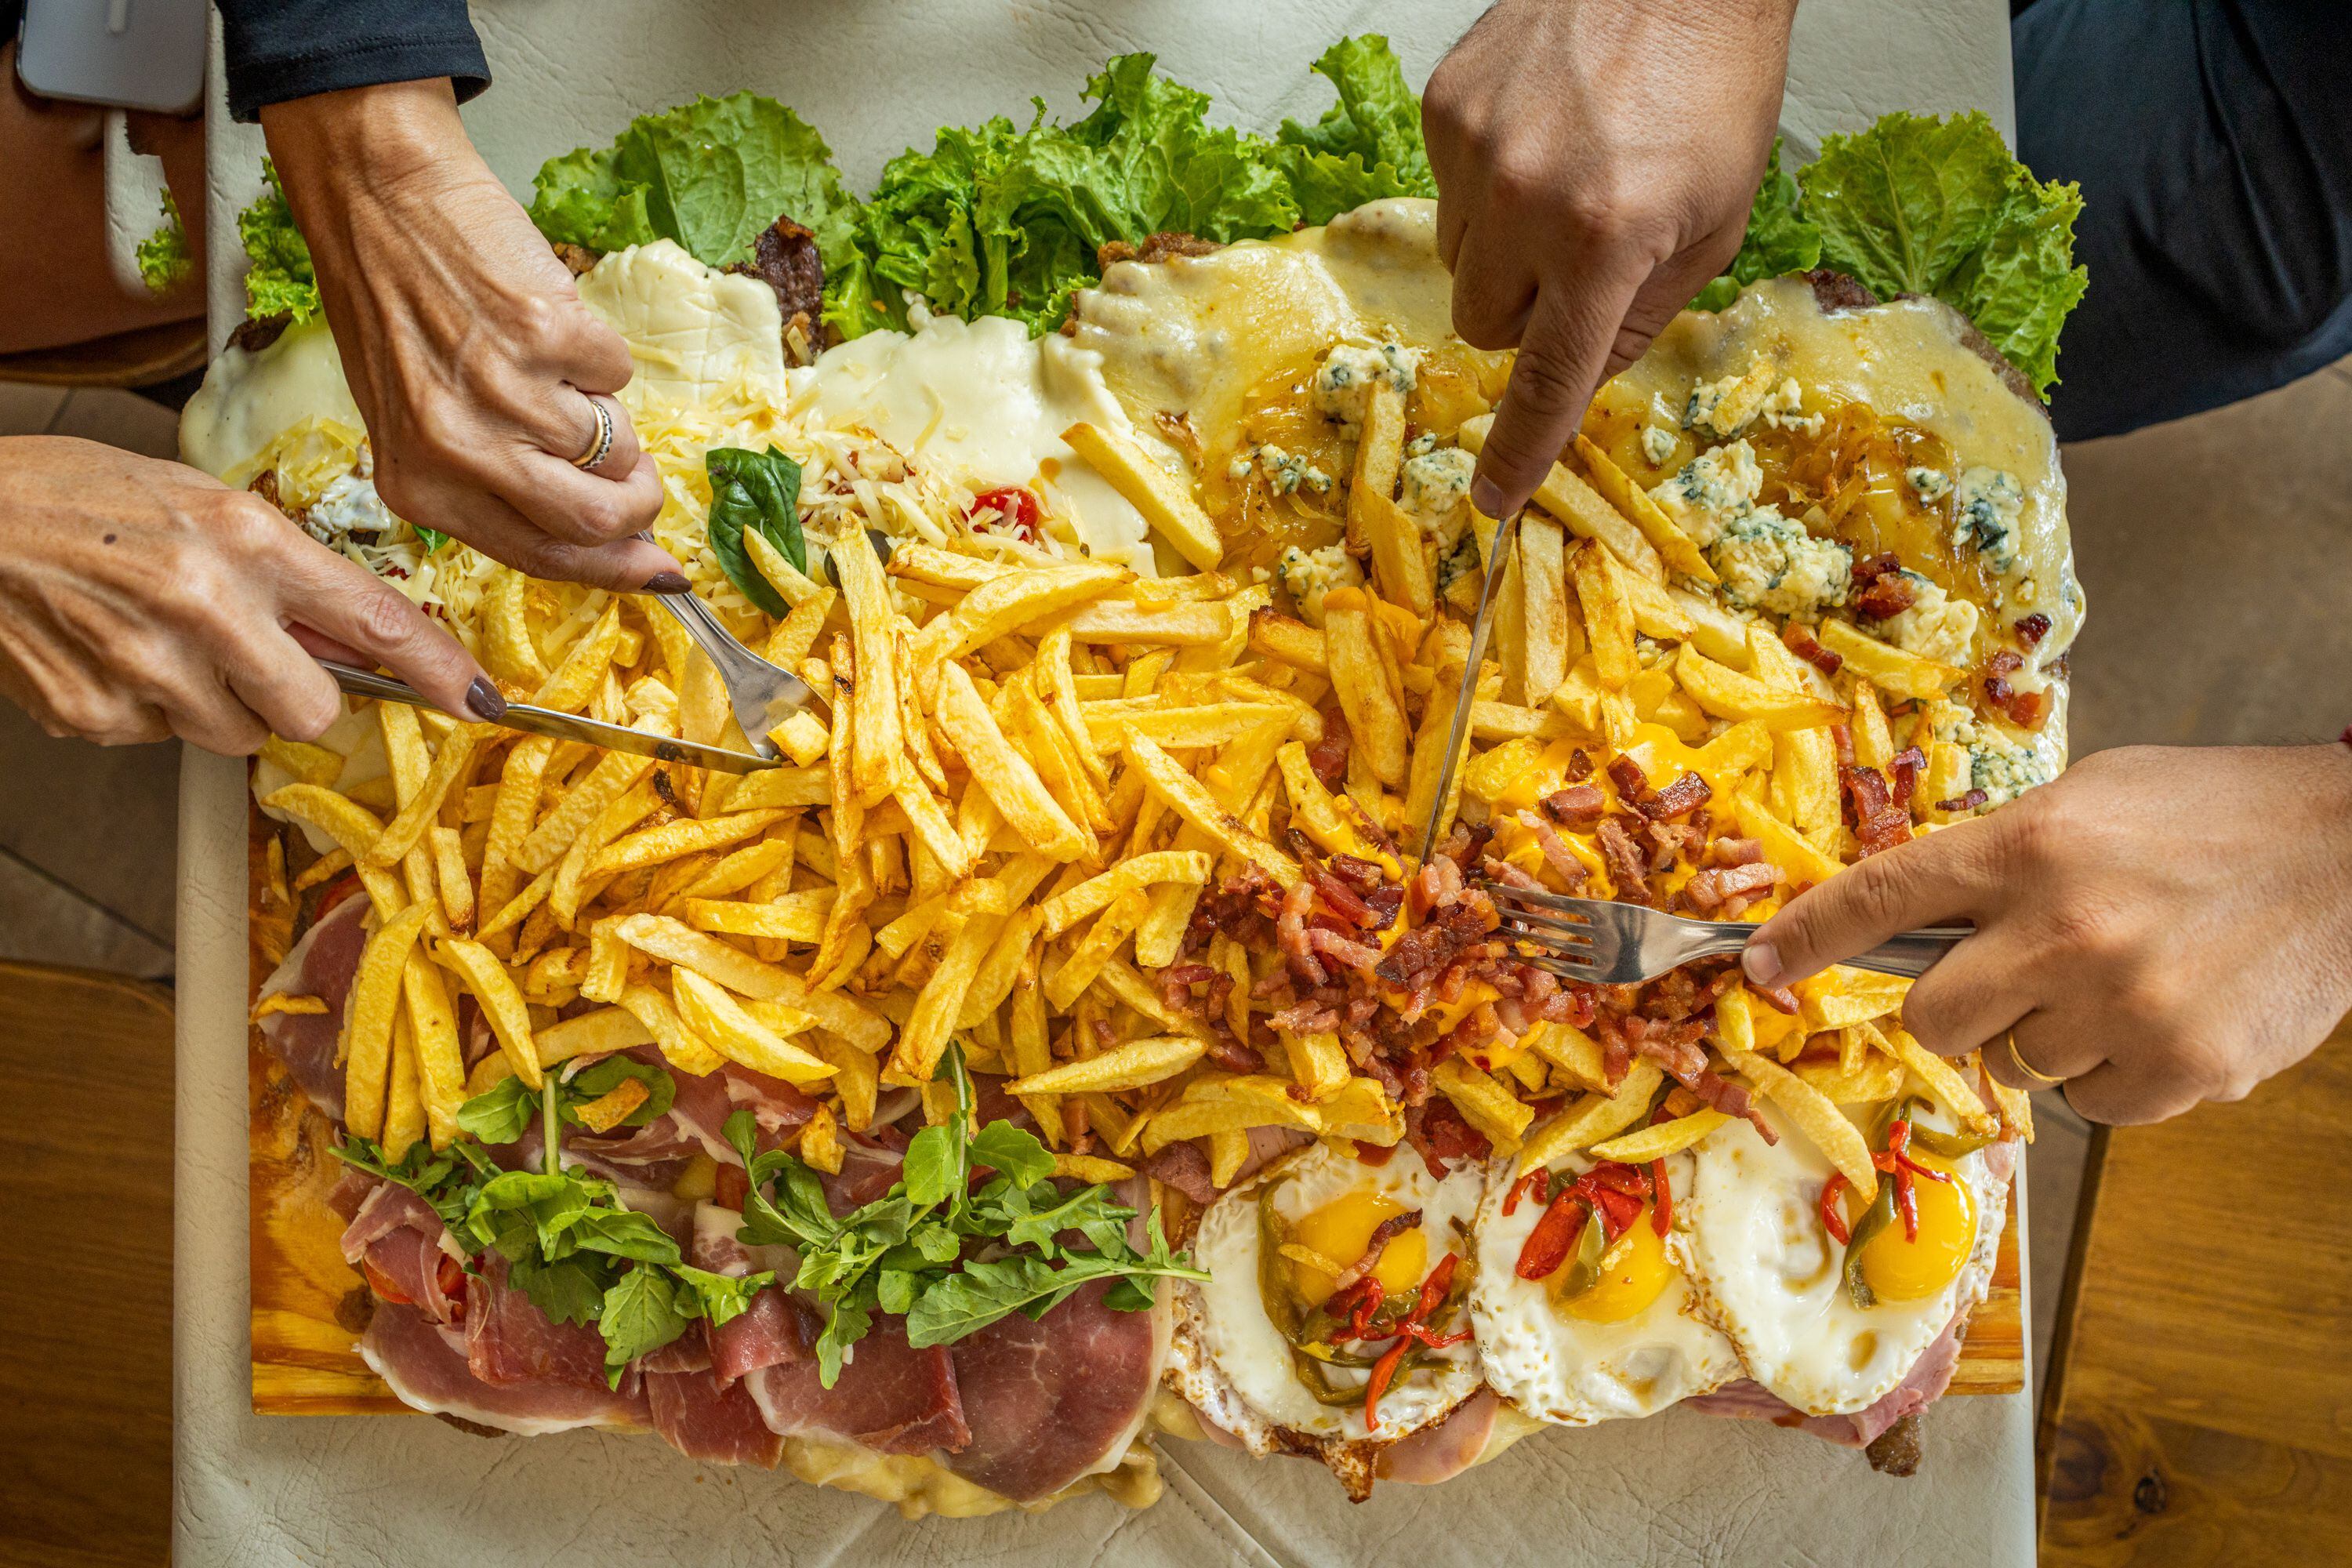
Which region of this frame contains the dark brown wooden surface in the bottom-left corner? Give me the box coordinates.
[0,961,172,1568]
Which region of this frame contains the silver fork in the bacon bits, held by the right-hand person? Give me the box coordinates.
[1479,881,1976,985]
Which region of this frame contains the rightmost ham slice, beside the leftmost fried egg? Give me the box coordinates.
[941,1281,1169,1502]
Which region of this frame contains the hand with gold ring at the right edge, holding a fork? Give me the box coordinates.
[1745,746,2352,1121]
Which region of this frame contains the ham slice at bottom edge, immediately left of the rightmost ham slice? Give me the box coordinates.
[743,1316,971,1453]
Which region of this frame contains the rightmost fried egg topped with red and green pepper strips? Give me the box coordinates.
[1677,1102,2009,1415]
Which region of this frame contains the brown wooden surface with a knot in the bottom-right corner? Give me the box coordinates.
[2039,1020,2352,1568]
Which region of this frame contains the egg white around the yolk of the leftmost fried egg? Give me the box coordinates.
[1169,1142,1484,1453]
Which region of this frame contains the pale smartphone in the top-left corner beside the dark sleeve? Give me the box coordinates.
[16,0,207,115]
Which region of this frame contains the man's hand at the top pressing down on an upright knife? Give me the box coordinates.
[1421,0,1797,517]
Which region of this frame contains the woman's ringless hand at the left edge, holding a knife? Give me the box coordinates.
[0,435,506,755]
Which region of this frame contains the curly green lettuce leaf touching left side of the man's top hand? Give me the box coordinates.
[1275,33,1437,223]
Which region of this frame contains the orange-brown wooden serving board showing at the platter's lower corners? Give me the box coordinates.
[247,806,2025,1415]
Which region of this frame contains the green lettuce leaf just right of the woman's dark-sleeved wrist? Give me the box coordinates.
[532,92,873,338]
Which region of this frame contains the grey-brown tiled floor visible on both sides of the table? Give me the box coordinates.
[0,352,2352,1387]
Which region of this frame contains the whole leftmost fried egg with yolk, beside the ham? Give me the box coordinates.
[1169,1142,1484,1490]
